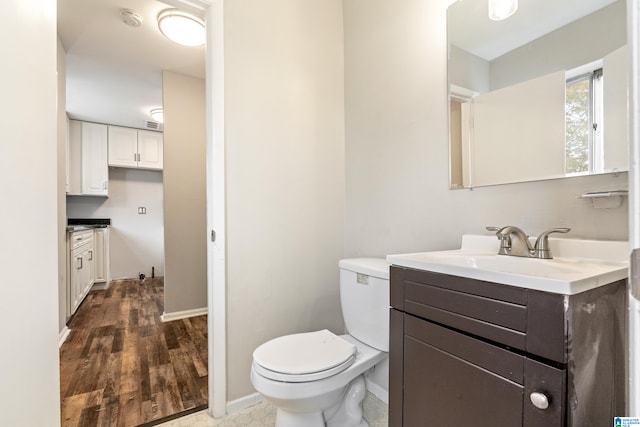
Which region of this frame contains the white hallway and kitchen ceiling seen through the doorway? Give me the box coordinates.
[58,0,205,128]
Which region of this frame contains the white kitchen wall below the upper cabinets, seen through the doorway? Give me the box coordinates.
[67,167,164,279]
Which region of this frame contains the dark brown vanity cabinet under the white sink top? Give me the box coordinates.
[389,266,626,427]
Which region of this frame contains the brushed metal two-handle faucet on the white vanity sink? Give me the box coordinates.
[487,225,571,259]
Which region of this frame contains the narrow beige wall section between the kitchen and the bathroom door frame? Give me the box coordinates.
[162,71,208,314]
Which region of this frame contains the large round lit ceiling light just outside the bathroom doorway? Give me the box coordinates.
[158,9,206,46]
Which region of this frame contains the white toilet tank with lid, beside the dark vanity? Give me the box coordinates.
[338,258,389,351]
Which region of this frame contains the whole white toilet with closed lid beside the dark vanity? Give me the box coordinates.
[251,258,389,427]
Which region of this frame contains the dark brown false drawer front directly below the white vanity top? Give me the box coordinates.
[391,266,566,363]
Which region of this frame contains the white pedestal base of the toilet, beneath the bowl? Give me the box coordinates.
[276,375,369,427]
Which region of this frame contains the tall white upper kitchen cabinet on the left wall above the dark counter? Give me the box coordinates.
[67,120,109,196]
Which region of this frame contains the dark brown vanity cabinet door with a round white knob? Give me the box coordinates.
[402,315,565,427]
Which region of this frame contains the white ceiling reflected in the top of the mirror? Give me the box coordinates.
[447,0,616,61]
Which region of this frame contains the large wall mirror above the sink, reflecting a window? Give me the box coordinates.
[447,0,628,189]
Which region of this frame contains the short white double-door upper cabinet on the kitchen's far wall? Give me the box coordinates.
[109,126,163,170]
